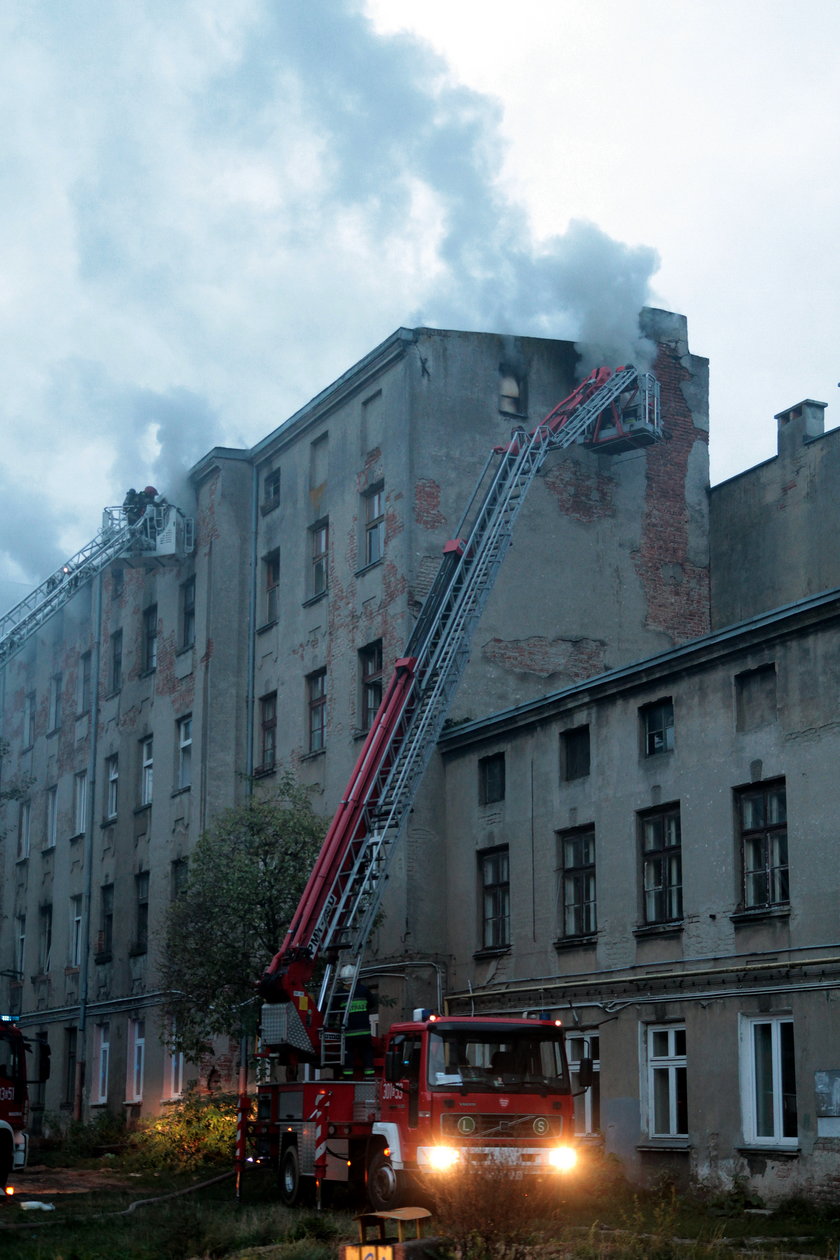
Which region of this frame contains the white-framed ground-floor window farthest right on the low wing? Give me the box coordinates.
[741,1016,797,1147]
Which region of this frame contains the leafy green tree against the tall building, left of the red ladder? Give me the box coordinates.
[161,772,326,1062]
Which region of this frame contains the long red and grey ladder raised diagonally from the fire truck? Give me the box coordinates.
[258,367,661,1066]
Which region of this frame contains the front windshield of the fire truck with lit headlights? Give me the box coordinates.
[427,1031,568,1092]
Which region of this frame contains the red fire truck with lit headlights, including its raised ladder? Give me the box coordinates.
[249,367,661,1211]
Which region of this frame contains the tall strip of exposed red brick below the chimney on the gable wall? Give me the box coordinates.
[633,347,710,643]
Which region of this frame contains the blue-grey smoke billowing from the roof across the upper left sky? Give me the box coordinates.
[0,0,657,581]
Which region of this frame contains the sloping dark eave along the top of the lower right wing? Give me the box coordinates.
[438,587,840,753]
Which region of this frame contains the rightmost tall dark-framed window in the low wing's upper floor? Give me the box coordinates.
[738,781,790,910]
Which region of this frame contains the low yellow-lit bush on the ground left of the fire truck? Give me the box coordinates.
[131,1091,237,1169]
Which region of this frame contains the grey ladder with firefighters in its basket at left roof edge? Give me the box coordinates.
[0,486,195,663]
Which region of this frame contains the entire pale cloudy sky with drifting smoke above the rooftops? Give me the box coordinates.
[0,0,840,593]
